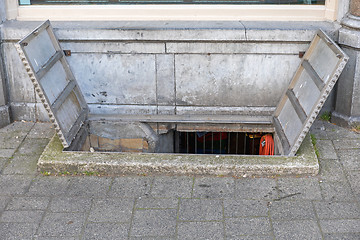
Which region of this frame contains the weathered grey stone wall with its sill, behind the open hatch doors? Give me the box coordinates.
[2,21,338,121]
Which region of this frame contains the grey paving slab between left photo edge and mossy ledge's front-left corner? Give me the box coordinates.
[3,154,39,175]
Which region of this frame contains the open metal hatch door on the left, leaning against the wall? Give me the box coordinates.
[16,21,88,148]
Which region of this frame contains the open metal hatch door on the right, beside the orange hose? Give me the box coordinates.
[273,30,348,156]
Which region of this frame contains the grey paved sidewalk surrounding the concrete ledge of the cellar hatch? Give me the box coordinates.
[0,121,360,240]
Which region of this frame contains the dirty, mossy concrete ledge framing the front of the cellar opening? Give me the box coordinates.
[38,132,319,177]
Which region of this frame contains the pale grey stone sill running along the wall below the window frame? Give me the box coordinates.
[2,21,339,42]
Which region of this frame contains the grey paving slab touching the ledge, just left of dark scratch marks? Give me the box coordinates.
[235,178,278,199]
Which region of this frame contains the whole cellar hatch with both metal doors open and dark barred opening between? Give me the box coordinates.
[17,21,348,156]
